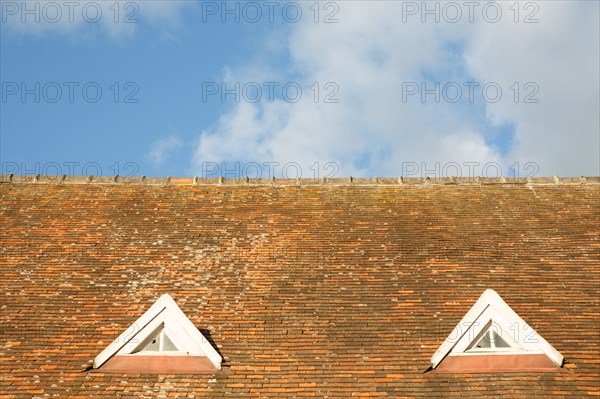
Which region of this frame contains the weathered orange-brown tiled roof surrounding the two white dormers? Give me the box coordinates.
[0,176,600,398]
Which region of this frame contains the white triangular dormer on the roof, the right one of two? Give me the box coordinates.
[431,289,564,373]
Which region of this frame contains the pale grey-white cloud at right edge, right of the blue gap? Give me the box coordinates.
[466,1,600,176]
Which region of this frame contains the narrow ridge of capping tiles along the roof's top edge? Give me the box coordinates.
[0,174,600,187]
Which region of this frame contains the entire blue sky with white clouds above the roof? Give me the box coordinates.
[0,0,600,178]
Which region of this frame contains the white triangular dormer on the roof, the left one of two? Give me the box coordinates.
[94,294,223,374]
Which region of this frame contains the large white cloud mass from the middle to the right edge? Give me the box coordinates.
[193,2,599,176]
